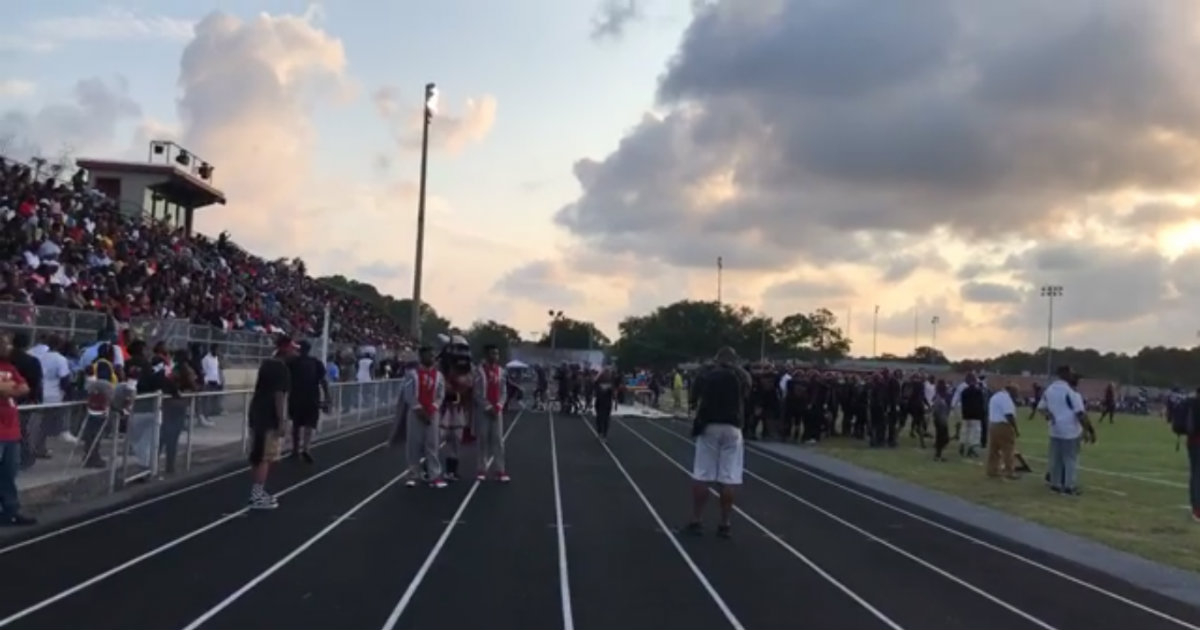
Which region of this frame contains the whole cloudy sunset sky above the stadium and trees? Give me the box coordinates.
[0,0,1200,358]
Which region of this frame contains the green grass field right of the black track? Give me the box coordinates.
[662,396,1200,571]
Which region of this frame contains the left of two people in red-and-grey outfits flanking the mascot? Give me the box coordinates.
[401,346,446,488]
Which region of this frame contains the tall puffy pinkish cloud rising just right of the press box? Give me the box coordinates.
[178,12,350,254]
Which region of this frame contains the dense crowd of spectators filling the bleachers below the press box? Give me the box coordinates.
[0,157,404,348]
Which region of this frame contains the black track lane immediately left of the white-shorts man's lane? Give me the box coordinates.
[554,414,730,630]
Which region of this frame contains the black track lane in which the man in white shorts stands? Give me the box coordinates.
[600,412,889,629]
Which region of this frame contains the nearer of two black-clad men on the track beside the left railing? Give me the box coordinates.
[247,335,296,510]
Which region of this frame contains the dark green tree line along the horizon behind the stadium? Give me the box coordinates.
[322,276,1200,388]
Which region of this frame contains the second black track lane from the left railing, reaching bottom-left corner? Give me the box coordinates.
[4,429,402,630]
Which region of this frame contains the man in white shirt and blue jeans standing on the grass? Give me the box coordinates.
[1038,366,1096,494]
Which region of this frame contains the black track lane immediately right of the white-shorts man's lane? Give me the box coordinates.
[620,420,1055,630]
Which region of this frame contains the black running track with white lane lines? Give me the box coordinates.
[0,413,1200,630]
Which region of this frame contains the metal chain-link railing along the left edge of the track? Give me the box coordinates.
[17,379,401,509]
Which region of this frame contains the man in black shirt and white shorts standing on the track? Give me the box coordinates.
[684,347,750,538]
